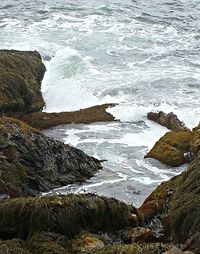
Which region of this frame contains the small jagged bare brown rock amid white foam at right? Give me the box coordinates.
[147,111,190,131]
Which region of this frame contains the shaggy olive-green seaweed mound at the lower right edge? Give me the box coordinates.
[170,158,200,253]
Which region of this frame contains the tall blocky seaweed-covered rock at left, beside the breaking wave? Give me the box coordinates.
[0,50,45,114]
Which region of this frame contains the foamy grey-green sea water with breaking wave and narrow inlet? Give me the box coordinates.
[0,0,200,206]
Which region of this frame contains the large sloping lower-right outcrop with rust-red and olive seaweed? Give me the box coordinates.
[139,157,200,254]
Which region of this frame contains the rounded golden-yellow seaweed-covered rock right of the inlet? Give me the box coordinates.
[145,131,194,167]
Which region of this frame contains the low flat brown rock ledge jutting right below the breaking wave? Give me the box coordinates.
[21,104,115,129]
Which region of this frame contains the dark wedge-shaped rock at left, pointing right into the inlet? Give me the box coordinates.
[0,117,101,196]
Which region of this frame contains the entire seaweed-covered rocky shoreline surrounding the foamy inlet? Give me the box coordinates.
[0,50,200,254]
